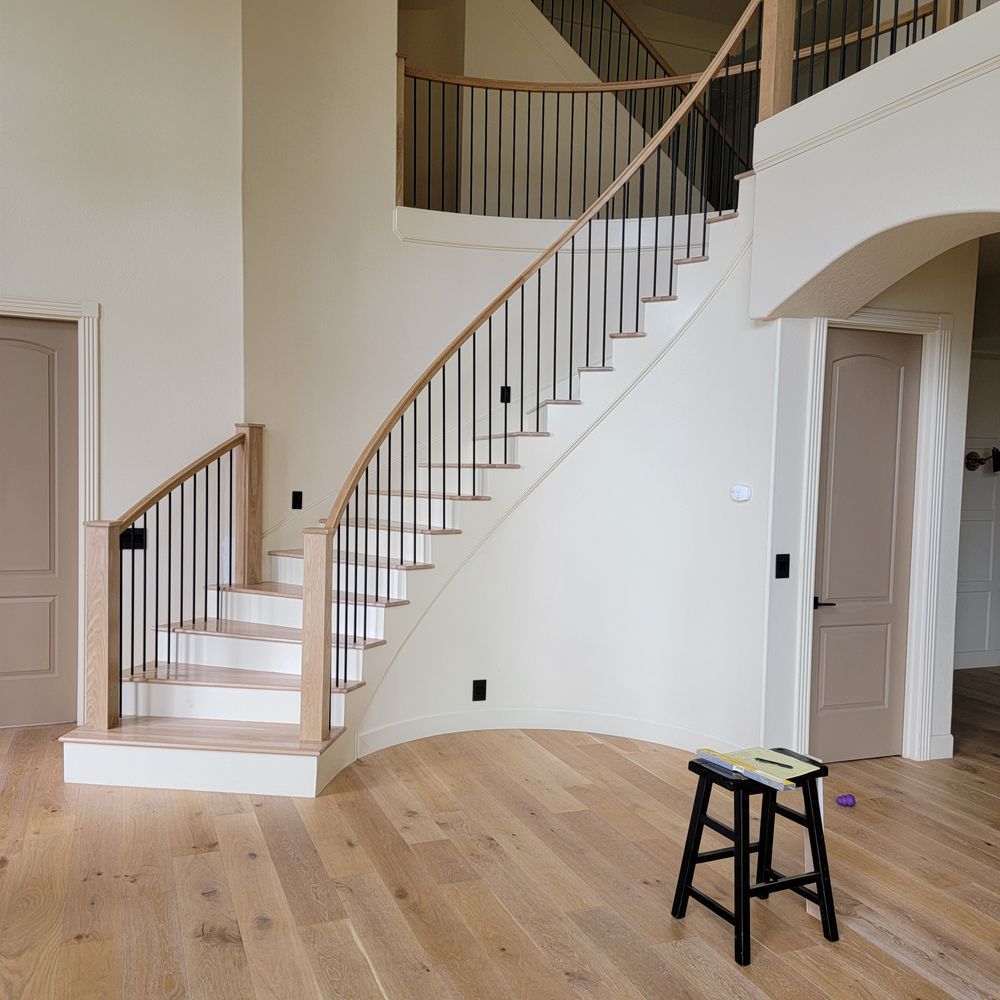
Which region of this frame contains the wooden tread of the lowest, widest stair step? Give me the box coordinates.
[60,715,344,757]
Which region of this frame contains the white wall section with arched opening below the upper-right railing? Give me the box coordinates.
[750,5,1000,317]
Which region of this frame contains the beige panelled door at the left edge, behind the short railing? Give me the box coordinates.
[0,317,79,726]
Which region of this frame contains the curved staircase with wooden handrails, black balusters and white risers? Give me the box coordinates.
[63,0,784,795]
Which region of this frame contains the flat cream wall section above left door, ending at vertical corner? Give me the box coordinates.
[0,0,243,517]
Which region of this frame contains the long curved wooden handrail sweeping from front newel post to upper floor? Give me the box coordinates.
[322,0,762,535]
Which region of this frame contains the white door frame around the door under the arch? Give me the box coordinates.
[794,308,952,760]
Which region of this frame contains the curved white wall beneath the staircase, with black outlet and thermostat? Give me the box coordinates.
[361,230,776,747]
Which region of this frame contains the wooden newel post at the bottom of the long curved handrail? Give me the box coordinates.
[299,528,333,742]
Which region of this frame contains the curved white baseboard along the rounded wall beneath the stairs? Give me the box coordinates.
[358,708,737,756]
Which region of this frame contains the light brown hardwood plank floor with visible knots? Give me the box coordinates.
[0,670,1000,1000]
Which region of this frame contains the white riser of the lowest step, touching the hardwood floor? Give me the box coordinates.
[63,743,333,798]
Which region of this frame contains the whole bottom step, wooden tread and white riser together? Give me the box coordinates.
[61,716,344,798]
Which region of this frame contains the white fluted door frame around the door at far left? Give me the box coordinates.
[0,295,101,720]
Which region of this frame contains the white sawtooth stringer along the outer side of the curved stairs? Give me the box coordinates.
[328,186,753,773]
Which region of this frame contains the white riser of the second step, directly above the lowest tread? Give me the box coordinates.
[122,681,345,726]
